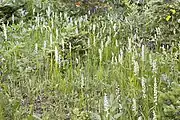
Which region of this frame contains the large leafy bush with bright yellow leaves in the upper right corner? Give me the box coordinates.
[111,0,180,49]
